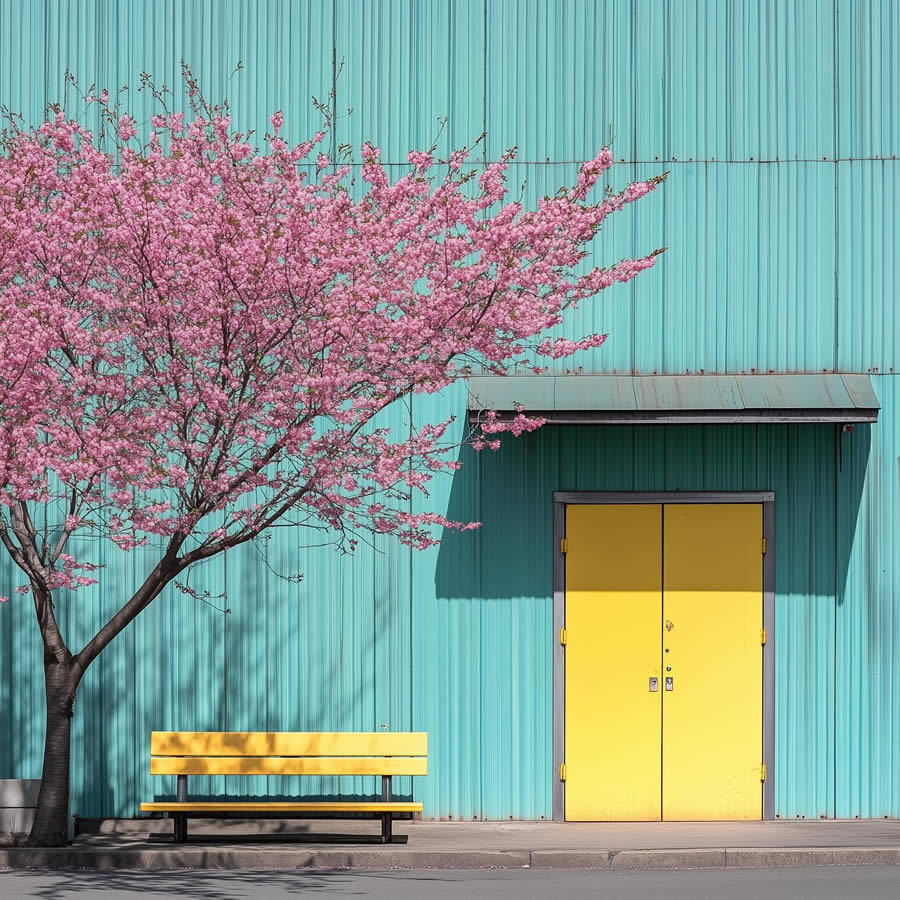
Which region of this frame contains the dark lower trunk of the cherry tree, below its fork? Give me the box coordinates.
[28,651,75,847]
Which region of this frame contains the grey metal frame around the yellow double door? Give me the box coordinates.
[553,491,775,822]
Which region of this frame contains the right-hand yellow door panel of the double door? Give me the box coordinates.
[662,504,762,820]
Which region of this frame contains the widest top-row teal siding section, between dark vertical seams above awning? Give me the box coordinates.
[486,0,834,162]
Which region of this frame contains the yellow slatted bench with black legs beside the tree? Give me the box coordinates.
[141,731,428,843]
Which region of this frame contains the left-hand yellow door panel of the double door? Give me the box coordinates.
[565,505,662,821]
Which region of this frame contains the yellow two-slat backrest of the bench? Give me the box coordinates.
[150,731,428,775]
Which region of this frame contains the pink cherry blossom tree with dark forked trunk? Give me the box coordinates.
[0,84,660,845]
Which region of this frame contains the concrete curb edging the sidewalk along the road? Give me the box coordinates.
[0,847,900,871]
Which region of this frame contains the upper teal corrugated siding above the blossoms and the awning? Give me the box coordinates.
[0,0,900,373]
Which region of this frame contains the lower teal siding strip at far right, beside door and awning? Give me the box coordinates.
[834,376,900,818]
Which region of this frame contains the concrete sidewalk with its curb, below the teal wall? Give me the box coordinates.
[0,819,900,869]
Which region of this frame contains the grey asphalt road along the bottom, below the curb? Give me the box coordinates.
[0,866,900,900]
